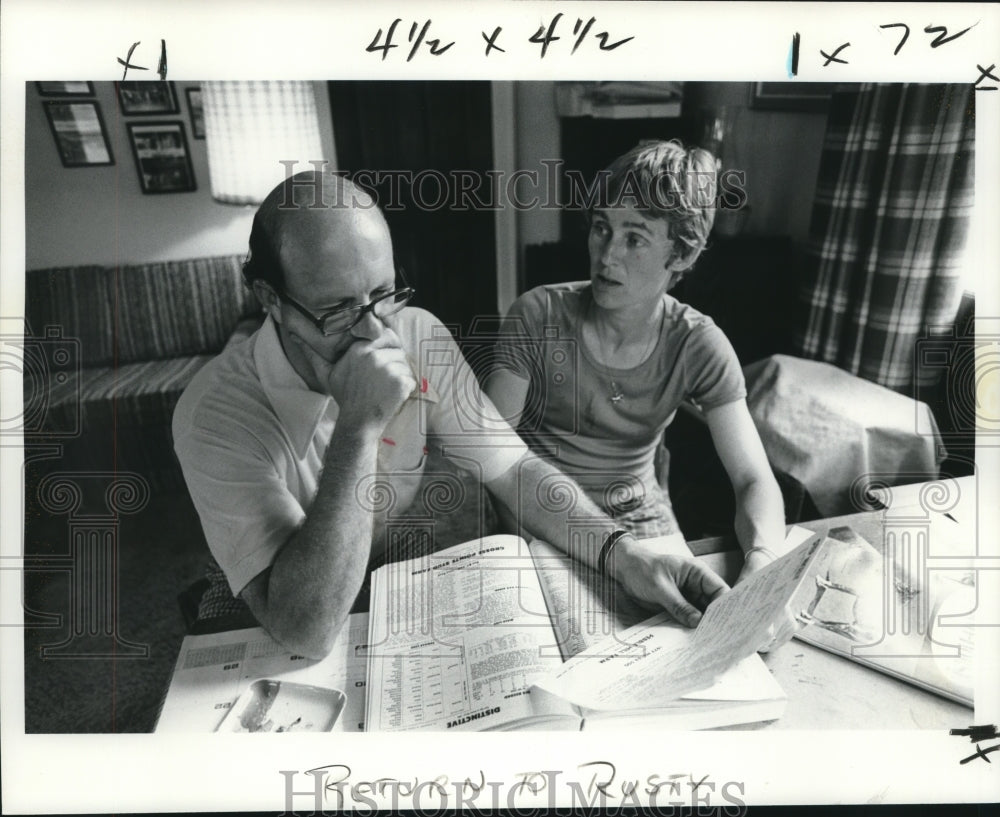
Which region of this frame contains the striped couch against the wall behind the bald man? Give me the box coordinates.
[25,256,260,488]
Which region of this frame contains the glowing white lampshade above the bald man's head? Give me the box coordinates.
[201,81,326,204]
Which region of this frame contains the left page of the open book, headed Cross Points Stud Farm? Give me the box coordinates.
[368,536,573,731]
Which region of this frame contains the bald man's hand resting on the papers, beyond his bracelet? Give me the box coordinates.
[612,536,729,627]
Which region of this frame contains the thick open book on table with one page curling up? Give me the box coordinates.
[365,536,822,731]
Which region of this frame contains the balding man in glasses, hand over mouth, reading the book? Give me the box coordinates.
[173,171,725,657]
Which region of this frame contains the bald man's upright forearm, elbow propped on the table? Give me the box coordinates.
[261,423,379,656]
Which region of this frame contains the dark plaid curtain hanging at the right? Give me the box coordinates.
[795,85,975,395]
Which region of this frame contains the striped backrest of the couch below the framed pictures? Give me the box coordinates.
[25,255,259,367]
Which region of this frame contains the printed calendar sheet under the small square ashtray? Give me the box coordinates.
[156,613,368,732]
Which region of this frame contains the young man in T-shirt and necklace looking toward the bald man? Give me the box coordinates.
[486,141,784,588]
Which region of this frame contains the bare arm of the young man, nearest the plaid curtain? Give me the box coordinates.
[705,400,785,578]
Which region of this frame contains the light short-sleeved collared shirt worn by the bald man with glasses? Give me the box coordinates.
[173,308,527,595]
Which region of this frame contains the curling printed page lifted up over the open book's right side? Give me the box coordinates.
[538,537,821,709]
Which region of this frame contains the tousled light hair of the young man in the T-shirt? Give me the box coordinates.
[587,139,718,266]
